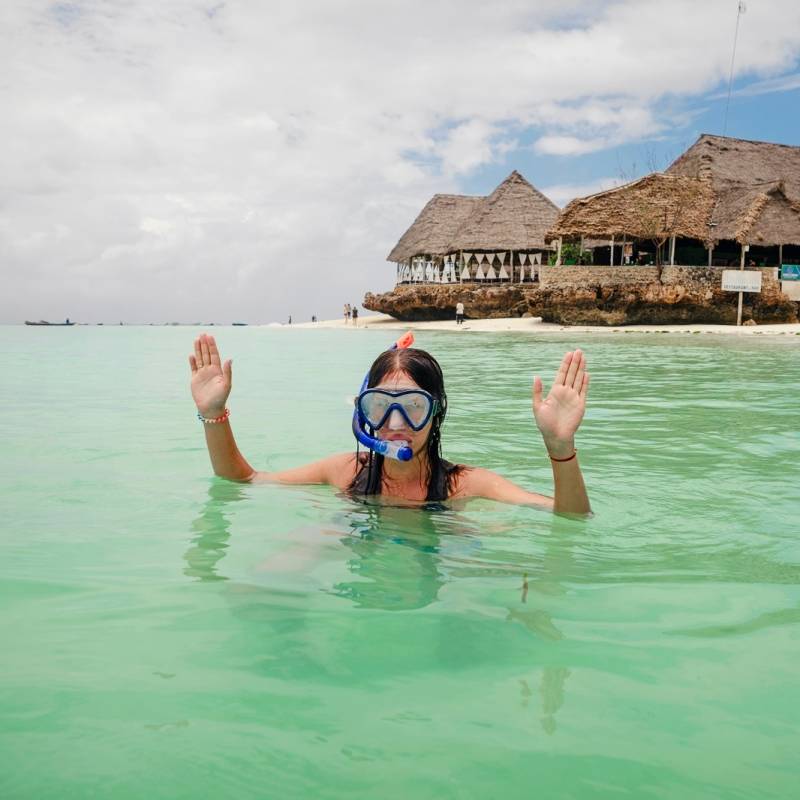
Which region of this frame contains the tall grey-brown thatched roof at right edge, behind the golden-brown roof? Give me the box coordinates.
[667,133,800,245]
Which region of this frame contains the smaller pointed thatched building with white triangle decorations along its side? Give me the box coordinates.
[387,170,559,284]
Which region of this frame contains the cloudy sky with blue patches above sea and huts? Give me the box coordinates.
[0,0,800,323]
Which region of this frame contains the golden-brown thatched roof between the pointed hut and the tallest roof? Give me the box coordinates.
[548,177,715,240]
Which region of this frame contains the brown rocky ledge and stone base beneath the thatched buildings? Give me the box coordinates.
[363,266,800,325]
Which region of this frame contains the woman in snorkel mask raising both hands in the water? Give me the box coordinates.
[189,334,591,514]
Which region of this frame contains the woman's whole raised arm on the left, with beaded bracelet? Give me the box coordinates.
[189,333,356,489]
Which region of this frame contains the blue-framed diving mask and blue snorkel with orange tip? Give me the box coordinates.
[353,331,422,461]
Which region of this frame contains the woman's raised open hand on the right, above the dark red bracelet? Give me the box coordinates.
[533,350,589,458]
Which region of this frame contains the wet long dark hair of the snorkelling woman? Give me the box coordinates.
[348,347,465,500]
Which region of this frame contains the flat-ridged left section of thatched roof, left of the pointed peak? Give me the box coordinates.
[386,194,483,261]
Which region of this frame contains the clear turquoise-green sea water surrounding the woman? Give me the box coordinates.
[0,327,800,800]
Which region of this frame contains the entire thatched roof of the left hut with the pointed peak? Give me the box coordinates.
[387,170,558,261]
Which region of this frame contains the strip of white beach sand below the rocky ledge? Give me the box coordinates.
[290,314,800,336]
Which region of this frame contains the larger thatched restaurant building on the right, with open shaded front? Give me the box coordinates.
[547,134,800,276]
